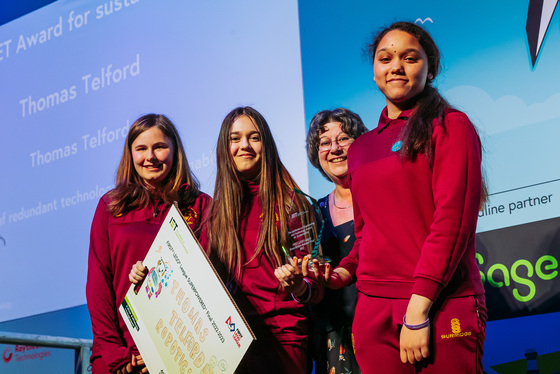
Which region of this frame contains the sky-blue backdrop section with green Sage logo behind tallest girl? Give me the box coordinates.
[299,0,560,373]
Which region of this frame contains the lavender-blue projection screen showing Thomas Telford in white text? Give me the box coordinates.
[0,0,308,373]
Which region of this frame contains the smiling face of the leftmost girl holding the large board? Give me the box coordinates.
[131,126,174,187]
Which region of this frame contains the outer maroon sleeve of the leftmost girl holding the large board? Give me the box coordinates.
[86,198,132,372]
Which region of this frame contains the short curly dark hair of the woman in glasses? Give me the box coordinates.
[306,108,368,181]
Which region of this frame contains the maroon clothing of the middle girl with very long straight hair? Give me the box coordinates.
[228,182,320,374]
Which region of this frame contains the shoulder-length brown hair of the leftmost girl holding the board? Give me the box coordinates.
[108,114,200,216]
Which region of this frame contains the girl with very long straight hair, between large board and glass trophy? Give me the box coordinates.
[206,107,320,374]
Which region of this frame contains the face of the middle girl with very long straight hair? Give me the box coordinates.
[229,116,263,180]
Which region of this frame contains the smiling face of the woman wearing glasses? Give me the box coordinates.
[318,122,354,185]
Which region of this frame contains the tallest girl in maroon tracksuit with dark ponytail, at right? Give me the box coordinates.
[308,22,486,374]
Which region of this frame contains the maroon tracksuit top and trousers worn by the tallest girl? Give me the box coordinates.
[340,108,485,373]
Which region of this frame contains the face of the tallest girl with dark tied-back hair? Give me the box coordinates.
[373,30,431,118]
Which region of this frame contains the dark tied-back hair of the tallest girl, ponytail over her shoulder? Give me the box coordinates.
[368,22,488,206]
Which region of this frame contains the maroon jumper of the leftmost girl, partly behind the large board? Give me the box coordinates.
[86,185,212,374]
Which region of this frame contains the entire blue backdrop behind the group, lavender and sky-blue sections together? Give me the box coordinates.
[0,0,560,373]
